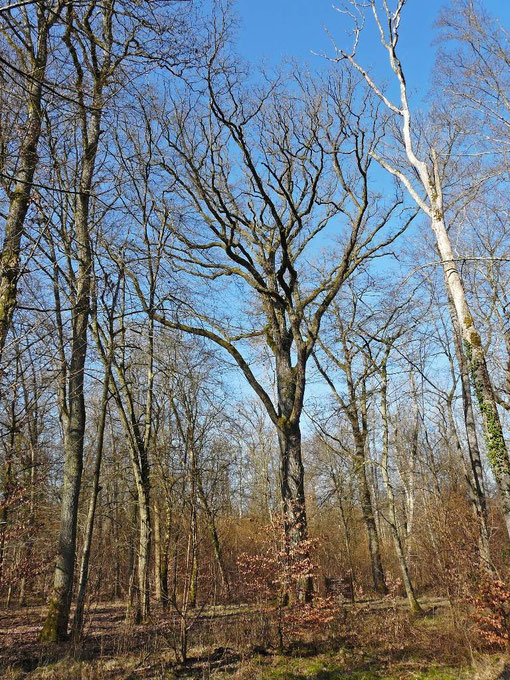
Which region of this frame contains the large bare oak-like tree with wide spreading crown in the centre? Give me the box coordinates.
[129,65,408,597]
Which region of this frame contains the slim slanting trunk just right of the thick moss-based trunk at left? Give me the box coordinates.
[73,366,110,638]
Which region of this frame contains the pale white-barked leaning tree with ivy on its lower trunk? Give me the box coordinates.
[337,0,510,534]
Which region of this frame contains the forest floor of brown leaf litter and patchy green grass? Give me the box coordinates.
[0,598,510,680]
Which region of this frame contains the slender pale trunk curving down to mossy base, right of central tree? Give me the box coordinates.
[380,359,422,614]
